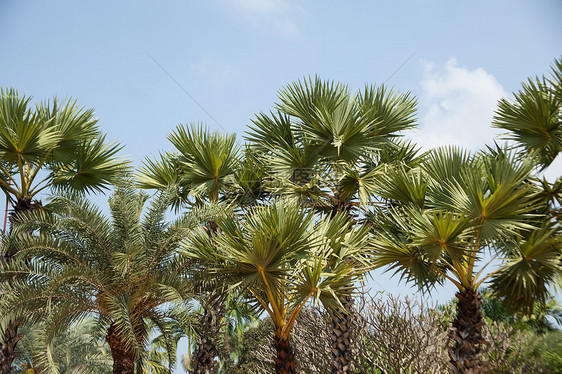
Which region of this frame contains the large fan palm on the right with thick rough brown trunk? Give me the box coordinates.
[372,148,562,373]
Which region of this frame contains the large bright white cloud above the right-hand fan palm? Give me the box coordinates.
[406,58,507,150]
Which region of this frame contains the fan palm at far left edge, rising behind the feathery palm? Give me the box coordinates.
[0,89,126,374]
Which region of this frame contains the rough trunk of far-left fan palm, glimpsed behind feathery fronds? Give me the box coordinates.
[0,196,41,374]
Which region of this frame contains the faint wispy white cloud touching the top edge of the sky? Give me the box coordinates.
[224,0,304,38]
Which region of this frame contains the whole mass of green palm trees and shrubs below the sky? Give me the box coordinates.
[0,59,562,374]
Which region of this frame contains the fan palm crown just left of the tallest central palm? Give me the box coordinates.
[137,124,264,209]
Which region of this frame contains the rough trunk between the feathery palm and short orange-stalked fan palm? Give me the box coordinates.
[193,296,225,374]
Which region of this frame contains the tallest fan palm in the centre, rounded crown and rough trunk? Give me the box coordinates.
[247,78,417,374]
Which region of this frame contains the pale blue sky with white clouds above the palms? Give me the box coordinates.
[0,0,562,368]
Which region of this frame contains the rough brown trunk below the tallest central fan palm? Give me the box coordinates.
[329,296,353,374]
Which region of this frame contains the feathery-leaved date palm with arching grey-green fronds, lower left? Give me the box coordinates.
[0,187,191,374]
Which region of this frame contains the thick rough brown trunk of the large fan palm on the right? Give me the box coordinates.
[447,289,488,374]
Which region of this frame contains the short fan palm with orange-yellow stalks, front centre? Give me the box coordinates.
[184,201,368,374]
